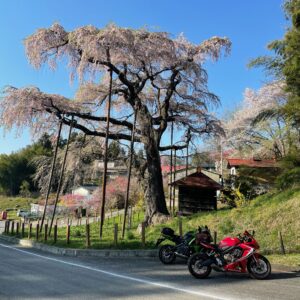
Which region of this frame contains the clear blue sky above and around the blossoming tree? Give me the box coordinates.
[0,0,287,153]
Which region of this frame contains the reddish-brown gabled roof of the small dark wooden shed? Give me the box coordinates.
[172,172,222,190]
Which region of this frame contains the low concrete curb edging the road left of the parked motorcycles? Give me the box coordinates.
[0,235,157,258]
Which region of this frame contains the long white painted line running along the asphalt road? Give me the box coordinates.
[0,243,233,300]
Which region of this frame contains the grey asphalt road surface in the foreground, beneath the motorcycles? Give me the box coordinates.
[0,242,300,300]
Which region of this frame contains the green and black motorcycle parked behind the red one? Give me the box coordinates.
[156,227,212,264]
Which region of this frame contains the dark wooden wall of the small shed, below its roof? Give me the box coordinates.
[178,187,217,215]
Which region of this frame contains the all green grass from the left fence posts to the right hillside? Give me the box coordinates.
[4,189,300,253]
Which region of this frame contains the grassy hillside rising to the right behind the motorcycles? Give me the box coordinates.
[147,188,300,252]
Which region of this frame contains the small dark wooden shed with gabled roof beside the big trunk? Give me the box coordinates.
[172,169,222,215]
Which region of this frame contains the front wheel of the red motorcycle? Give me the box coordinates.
[247,255,271,279]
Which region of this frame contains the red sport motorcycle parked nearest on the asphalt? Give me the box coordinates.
[188,231,271,279]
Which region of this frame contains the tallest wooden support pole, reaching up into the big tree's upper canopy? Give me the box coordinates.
[100,64,113,240]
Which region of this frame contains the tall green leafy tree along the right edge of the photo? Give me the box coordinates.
[250,0,300,188]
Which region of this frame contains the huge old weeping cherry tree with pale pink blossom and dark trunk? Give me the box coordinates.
[0,24,230,223]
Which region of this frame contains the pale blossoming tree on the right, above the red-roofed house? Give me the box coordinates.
[224,81,292,159]
